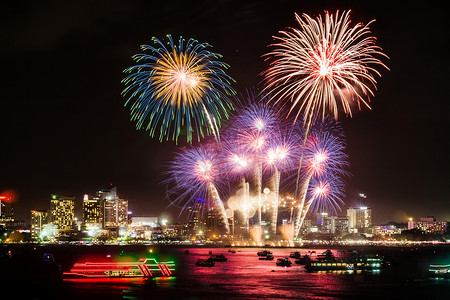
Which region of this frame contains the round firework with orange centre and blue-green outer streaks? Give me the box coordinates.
[122,35,235,142]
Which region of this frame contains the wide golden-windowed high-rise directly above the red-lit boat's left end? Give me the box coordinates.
[50,195,75,231]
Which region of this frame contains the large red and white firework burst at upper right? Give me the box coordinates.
[264,11,387,126]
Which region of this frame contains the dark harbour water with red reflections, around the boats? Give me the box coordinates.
[0,246,450,299]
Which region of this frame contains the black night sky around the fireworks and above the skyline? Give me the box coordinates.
[0,0,450,223]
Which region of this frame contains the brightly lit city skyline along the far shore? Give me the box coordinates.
[20,187,448,245]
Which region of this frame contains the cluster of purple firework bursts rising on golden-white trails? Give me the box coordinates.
[167,103,348,240]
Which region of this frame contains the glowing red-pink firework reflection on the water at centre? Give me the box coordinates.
[176,248,356,299]
